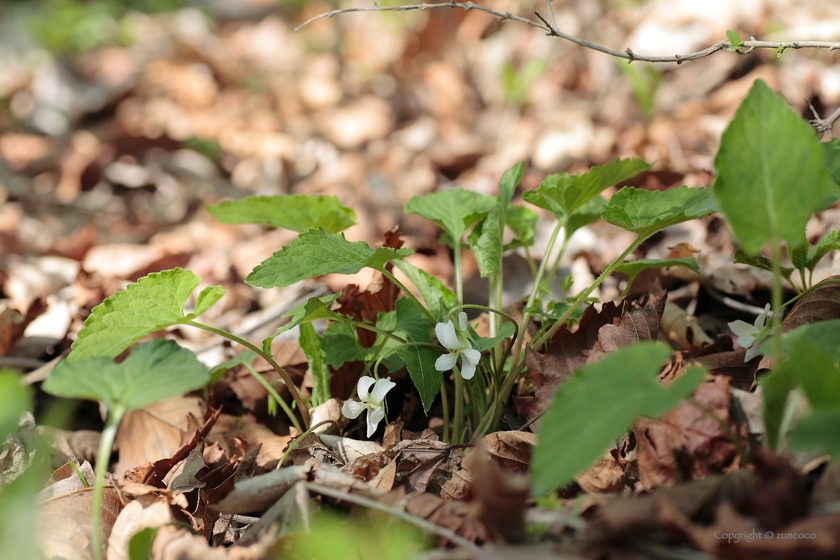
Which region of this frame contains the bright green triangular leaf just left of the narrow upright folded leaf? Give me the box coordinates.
[405,188,496,239]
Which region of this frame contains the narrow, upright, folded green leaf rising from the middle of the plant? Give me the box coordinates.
[470,161,524,278]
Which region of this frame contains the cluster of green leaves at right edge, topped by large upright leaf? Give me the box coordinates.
[713,80,840,464]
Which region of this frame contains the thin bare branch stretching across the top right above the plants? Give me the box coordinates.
[295,0,840,64]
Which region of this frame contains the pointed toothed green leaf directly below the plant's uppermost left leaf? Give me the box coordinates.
[245,229,412,288]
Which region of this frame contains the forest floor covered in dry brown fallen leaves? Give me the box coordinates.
[0,0,840,560]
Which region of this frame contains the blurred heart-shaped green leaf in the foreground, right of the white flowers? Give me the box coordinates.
[531,343,705,496]
